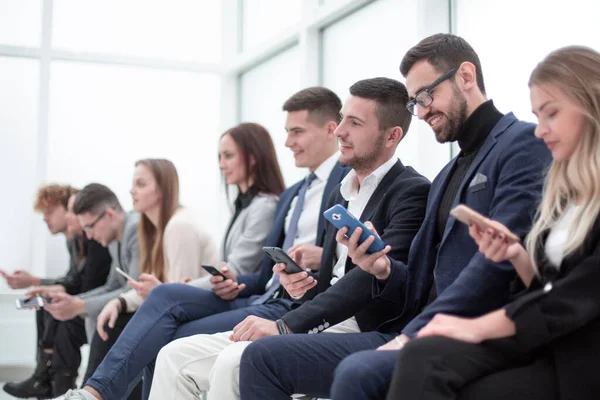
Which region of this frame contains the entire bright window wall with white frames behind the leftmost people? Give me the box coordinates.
[0,0,223,285]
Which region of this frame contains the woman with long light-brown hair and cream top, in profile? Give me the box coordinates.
[96,159,217,328]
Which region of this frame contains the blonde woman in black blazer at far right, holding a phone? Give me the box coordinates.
[388,46,600,400]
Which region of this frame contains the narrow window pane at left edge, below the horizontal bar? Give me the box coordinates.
[0,57,39,276]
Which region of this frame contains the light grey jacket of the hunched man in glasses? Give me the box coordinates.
[80,211,140,318]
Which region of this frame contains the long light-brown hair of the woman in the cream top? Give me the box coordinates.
[135,158,179,282]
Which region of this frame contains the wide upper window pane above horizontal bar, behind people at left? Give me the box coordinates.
[52,0,221,62]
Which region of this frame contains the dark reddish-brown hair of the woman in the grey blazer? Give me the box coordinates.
[221,123,285,196]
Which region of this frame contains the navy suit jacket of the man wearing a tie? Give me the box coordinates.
[237,162,350,297]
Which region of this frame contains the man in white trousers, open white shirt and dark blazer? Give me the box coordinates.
[145,78,429,400]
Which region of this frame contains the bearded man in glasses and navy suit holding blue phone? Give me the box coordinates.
[239,34,551,400]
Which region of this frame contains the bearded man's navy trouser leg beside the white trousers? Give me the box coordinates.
[240,332,396,400]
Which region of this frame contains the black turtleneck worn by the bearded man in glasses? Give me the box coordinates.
[437,100,503,243]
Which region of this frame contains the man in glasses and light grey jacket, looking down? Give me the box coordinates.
[45,183,140,383]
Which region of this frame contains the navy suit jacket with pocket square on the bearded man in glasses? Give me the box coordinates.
[373,113,551,336]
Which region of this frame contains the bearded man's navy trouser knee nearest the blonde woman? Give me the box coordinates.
[331,350,400,400]
